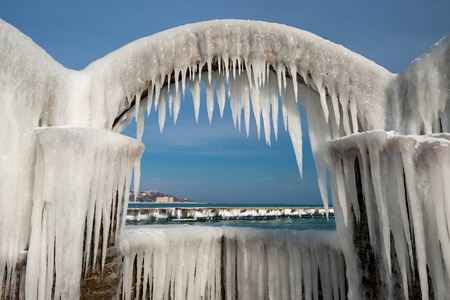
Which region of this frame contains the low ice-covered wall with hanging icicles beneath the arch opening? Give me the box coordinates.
[122,226,346,300]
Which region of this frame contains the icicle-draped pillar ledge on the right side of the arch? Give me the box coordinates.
[330,131,450,299]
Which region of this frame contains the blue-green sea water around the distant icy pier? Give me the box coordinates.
[127,203,336,230]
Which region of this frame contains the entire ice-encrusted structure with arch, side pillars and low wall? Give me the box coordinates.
[0,20,450,299]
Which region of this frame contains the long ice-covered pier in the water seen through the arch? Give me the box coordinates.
[127,207,334,222]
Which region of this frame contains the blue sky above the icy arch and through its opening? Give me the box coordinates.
[0,0,450,204]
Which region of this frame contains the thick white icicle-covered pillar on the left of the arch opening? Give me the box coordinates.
[24,127,143,299]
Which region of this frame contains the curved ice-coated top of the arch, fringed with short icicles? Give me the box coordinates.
[83,20,393,133]
